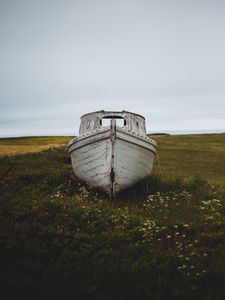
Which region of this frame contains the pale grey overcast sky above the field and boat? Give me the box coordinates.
[0,0,225,136]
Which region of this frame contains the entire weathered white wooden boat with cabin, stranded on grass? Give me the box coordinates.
[68,110,157,197]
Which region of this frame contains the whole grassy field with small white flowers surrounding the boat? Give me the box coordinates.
[0,134,225,300]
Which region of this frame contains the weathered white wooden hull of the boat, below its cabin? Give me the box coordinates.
[68,127,156,196]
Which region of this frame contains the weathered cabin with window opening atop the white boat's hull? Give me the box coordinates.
[79,110,146,136]
